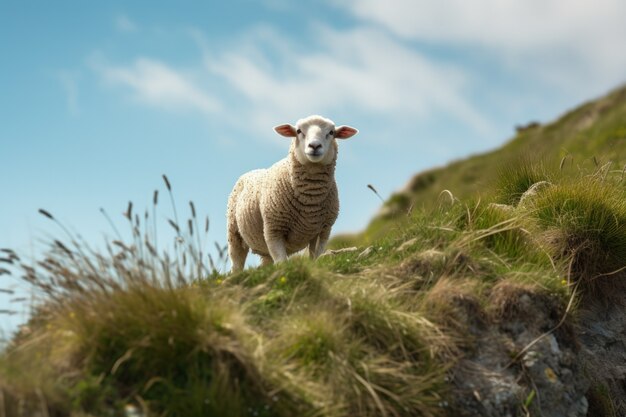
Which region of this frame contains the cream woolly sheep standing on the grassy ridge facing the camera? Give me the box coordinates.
[226,116,358,272]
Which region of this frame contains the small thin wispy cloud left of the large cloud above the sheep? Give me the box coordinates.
[90,58,221,114]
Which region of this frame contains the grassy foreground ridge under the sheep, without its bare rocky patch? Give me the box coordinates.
[0,86,626,417]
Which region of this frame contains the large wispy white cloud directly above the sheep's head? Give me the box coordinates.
[205,25,488,134]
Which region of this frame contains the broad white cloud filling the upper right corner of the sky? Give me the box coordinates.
[331,0,626,92]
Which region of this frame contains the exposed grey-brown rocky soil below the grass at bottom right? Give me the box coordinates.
[448,277,626,417]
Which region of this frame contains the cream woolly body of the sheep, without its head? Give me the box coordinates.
[227,141,339,261]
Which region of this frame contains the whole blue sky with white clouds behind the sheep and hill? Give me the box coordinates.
[0,0,626,329]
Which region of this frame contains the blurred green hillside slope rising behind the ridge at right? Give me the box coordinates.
[334,86,626,247]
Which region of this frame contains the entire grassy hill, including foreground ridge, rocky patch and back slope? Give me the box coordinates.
[0,85,626,417]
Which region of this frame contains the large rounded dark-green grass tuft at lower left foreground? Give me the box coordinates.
[58,285,264,416]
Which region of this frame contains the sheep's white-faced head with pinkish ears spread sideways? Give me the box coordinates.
[274,116,358,164]
